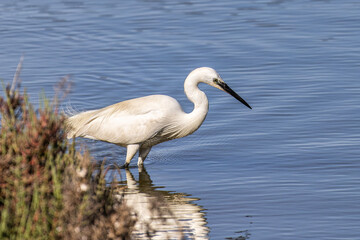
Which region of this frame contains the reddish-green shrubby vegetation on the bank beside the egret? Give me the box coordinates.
[0,79,136,239]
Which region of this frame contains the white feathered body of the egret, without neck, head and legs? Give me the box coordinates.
[68,95,206,147]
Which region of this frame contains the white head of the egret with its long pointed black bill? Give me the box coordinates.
[190,67,252,109]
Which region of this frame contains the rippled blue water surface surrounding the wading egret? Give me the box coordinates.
[0,0,360,240]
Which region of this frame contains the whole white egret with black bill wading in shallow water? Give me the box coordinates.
[67,67,251,167]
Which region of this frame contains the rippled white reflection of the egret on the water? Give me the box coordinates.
[114,167,209,239]
